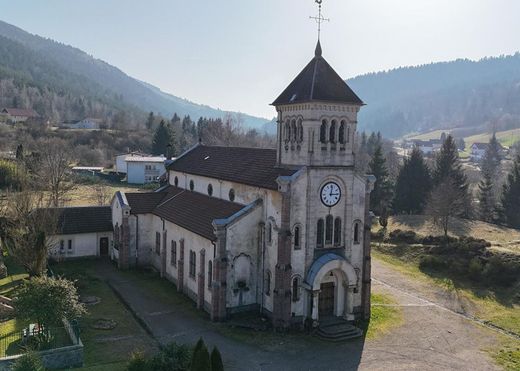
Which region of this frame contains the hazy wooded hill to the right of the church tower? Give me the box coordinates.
[347,53,520,138]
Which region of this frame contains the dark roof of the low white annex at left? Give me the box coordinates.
[39,206,112,234]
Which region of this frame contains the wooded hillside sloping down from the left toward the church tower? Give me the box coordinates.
[0,21,268,129]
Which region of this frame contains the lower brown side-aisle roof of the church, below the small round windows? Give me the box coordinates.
[126,186,248,240]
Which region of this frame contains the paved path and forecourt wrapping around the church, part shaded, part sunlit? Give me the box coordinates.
[90,261,504,371]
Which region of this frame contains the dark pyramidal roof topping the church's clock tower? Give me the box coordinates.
[272,40,364,106]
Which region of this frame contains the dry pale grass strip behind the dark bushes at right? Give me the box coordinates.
[380,215,520,254]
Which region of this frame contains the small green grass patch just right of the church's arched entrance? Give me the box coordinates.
[366,293,403,340]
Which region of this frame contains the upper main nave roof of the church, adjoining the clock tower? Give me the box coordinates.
[168,145,298,190]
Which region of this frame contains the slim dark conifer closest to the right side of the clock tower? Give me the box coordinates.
[368,144,391,215]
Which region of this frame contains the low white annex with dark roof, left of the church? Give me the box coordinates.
[49,206,113,260]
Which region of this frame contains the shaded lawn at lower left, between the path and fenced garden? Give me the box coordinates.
[53,260,156,370]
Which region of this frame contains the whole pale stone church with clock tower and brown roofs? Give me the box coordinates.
[111,41,375,328]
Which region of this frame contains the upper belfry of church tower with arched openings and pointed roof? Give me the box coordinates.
[272,40,364,167]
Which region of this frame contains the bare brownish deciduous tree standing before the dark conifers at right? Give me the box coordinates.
[426,177,464,237]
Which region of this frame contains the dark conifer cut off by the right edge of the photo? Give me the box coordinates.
[501,155,520,229]
